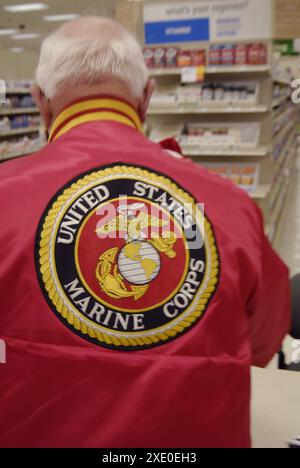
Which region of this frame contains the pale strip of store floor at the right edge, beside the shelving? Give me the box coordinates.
[279,155,300,276]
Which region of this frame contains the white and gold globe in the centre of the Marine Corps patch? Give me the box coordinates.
[118,242,161,285]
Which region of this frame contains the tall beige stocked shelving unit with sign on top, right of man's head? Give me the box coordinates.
[116,0,300,246]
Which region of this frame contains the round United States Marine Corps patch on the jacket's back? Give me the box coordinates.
[36,165,219,351]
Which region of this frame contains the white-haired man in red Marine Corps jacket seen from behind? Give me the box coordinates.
[0,17,290,448]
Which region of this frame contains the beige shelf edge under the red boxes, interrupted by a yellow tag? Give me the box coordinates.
[149,65,270,77]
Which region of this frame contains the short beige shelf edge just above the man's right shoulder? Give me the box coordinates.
[181,145,270,159]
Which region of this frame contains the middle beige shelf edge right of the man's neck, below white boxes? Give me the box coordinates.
[148,104,269,115]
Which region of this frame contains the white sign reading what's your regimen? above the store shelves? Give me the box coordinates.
[144,0,273,42]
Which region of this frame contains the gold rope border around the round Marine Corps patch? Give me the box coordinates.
[39,166,219,348]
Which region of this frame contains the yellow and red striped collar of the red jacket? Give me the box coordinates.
[49,95,142,143]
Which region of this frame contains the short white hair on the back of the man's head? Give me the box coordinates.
[36,17,149,99]
